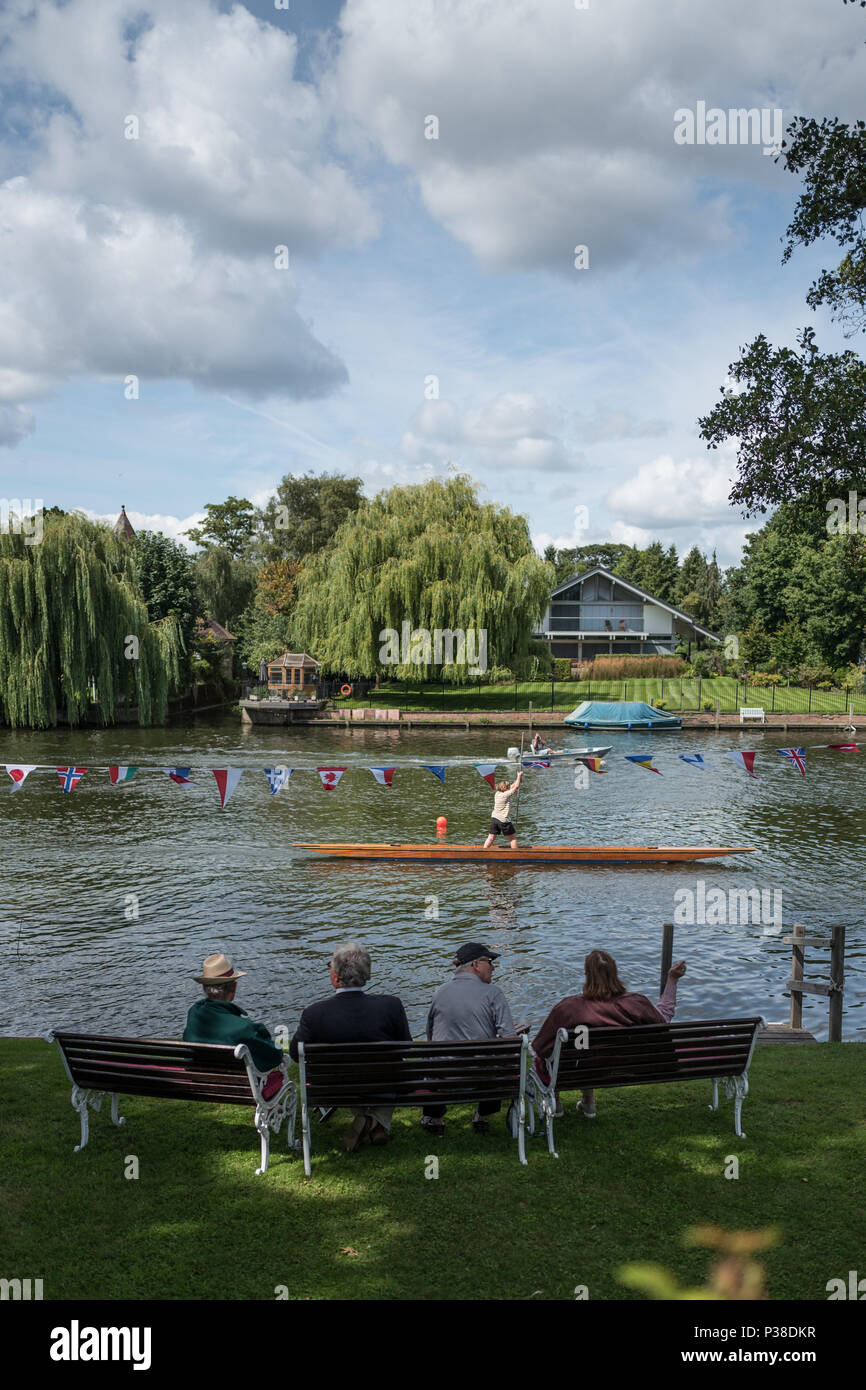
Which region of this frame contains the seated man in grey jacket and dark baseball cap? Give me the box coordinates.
[421,941,514,1136]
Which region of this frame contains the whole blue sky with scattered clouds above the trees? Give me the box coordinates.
[0,0,866,564]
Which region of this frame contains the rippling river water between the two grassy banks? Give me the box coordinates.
[0,716,866,1040]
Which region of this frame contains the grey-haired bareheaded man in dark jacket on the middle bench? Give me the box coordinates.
[289,941,411,1154]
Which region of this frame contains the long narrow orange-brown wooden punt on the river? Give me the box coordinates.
[293,842,752,865]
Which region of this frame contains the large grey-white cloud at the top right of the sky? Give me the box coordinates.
[338,0,862,275]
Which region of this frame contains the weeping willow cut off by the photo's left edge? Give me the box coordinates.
[0,513,183,728]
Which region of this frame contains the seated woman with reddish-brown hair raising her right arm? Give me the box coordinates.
[532,951,685,1119]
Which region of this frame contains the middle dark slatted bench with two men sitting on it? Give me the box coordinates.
[297,1036,530,1177]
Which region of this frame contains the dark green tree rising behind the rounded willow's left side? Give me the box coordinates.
[260,473,364,560]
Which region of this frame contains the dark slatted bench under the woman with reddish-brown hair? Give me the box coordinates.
[527,1017,763,1158]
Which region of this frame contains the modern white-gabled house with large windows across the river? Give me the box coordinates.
[535,567,721,662]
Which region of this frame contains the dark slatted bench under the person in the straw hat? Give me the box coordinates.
[52,1031,300,1173]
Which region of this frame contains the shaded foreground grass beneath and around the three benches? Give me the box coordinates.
[0,1040,866,1300]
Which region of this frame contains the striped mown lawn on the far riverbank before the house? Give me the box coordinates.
[334,676,866,714]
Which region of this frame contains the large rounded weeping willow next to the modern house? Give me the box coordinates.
[292,477,553,680]
